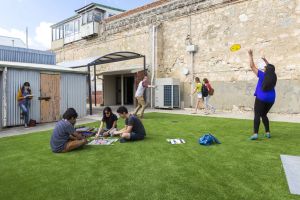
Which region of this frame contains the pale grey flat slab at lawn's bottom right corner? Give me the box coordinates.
[280,155,300,195]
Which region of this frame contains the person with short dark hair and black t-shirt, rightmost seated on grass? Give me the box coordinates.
[116,106,146,143]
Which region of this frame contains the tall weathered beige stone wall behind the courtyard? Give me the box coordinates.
[56,0,300,113]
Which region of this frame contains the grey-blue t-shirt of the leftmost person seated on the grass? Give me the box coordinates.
[50,119,75,153]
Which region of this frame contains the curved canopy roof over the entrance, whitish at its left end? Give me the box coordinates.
[58,51,145,68]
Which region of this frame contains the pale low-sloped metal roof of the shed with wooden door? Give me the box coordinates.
[0,61,87,74]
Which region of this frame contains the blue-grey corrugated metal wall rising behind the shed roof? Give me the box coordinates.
[0,45,56,65]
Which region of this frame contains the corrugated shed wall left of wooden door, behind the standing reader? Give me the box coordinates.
[6,68,40,126]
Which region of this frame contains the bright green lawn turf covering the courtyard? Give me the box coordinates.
[0,113,300,200]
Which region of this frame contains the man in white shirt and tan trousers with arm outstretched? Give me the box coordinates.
[133,76,156,118]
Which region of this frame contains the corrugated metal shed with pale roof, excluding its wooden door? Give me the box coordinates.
[0,61,88,127]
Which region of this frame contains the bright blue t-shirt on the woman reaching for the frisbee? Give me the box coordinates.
[254,70,276,103]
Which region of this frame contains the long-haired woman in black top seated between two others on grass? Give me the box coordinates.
[96,107,118,137]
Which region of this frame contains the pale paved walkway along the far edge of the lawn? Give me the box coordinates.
[0,106,300,138]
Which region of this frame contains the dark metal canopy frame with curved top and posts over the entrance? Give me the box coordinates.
[85,51,147,115]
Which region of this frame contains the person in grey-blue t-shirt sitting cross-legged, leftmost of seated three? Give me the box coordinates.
[50,108,87,153]
